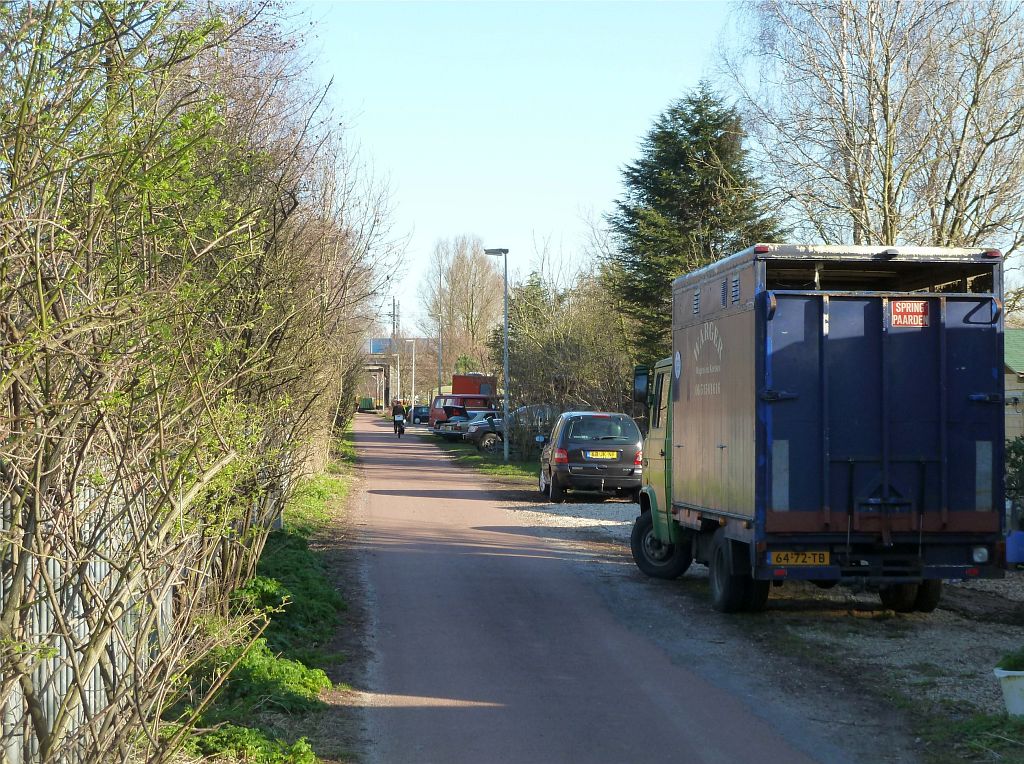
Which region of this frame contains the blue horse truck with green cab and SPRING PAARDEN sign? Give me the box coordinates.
[631,244,1004,612]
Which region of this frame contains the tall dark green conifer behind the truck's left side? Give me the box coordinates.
[602,83,781,363]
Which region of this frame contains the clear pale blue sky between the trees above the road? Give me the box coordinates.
[297,1,729,330]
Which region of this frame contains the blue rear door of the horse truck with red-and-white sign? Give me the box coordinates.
[759,292,1004,543]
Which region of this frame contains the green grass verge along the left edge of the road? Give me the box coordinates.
[186,432,355,764]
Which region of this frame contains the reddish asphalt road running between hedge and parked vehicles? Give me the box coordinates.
[355,415,906,764]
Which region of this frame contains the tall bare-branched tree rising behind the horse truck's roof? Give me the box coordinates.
[722,0,1024,266]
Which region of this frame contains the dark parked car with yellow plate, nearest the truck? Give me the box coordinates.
[538,412,643,502]
